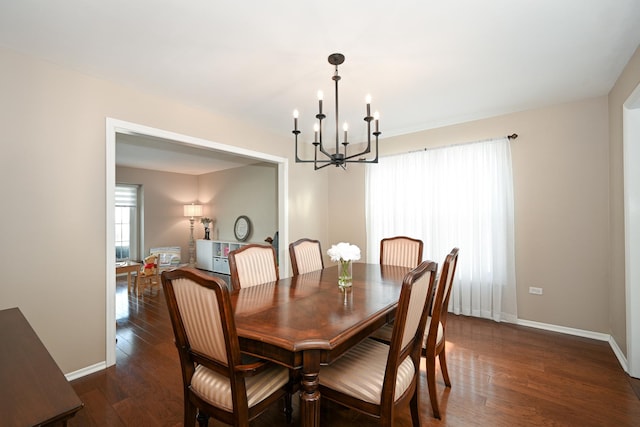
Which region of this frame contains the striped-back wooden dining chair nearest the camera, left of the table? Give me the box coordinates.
[162,268,291,427]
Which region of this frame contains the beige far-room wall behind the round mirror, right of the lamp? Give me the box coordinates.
[198,163,278,244]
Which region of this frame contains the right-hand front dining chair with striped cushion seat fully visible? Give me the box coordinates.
[319,261,437,426]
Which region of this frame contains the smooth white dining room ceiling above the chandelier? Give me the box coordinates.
[0,0,640,174]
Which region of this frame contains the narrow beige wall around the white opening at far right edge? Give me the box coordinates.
[608,48,640,354]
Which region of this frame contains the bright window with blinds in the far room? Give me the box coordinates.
[115,184,140,261]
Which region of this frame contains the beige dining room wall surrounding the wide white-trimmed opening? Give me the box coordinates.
[0,48,327,373]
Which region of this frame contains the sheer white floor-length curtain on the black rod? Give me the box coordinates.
[366,138,517,322]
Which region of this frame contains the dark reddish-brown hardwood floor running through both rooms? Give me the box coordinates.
[69,278,640,427]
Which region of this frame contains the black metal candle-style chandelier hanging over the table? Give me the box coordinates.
[293,53,382,170]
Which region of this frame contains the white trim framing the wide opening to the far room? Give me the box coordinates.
[105,118,289,367]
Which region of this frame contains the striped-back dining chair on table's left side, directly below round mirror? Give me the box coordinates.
[229,243,280,290]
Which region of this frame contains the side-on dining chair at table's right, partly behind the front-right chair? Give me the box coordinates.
[422,248,459,419]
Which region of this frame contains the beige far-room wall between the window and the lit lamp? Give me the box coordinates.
[116,166,198,262]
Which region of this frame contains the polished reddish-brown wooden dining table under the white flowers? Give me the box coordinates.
[231,263,410,426]
